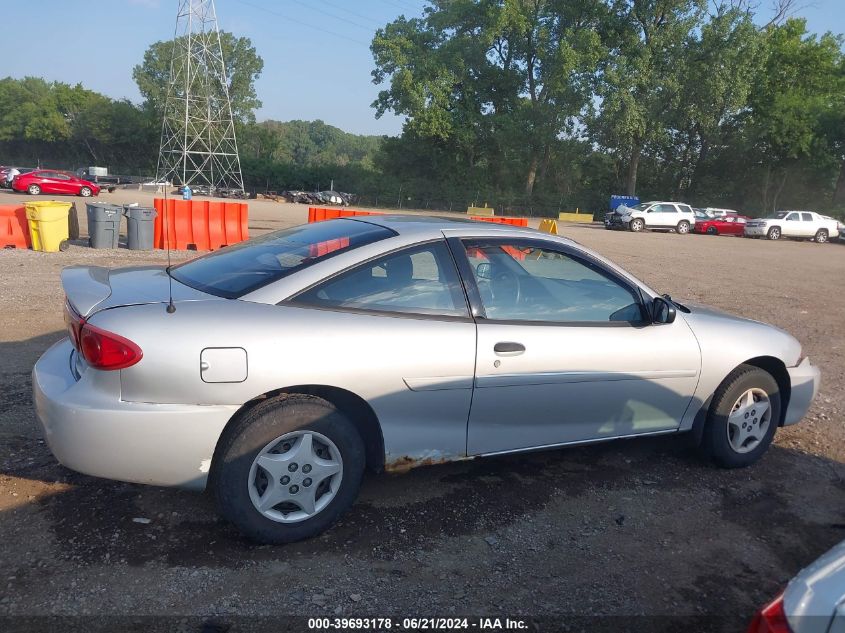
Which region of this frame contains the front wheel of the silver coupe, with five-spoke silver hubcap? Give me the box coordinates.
[701,365,781,468]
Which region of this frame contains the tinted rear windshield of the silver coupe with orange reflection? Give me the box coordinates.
[170,220,396,299]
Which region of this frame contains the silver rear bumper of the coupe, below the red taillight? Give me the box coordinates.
[32,339,238,489]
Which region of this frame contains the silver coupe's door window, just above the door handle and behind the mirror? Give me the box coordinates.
[464,241,643,323]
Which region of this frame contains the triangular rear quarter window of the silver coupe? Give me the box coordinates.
[293,241,469,317]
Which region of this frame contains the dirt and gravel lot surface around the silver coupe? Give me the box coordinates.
[0,185,845,630]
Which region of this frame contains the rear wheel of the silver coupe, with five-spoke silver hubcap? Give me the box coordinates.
[213,394,365,544]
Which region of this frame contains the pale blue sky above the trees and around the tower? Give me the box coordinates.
[0,0,845,134]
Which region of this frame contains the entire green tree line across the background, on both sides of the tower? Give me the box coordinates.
[0,0,845,215]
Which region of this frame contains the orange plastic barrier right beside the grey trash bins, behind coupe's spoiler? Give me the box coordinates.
[153,198,249,251]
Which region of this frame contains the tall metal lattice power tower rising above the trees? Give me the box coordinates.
[156,0,244,192]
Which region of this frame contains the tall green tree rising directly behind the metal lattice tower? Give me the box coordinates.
[132,31,264,122]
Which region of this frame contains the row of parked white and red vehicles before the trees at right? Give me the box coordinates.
[604,201,845,244]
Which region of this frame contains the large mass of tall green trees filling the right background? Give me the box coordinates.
[372,0,845,213]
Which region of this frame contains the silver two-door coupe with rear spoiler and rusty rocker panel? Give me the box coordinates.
[33,215,819,543]
